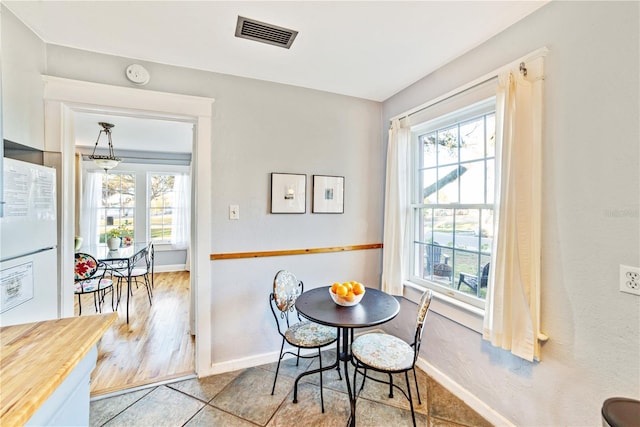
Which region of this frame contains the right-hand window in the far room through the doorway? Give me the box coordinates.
[149,174,176,242]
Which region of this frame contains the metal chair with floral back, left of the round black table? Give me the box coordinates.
[269,270,342,413]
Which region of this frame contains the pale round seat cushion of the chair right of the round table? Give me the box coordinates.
[351,333,414,371]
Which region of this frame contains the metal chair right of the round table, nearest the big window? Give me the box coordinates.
[351,290,432,427]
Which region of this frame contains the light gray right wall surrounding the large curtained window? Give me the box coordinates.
[383,2,640,426]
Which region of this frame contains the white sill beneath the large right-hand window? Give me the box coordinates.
[403,282,484,334]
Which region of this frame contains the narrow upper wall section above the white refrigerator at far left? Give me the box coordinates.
[0,6,46,150]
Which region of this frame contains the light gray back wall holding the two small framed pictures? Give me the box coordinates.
[47,45,384,372]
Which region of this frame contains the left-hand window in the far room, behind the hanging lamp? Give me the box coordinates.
[98,172,136,243]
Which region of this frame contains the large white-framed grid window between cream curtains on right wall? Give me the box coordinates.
[410,98,496,307]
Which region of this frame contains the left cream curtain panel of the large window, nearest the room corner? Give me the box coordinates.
[382,119,411,295]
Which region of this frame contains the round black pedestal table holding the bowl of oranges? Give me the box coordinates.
[295,286,400,426]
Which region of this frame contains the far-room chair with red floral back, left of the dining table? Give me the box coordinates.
[74,252,113,316]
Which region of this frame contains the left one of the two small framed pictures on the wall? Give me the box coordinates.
[271,173,307,213]
